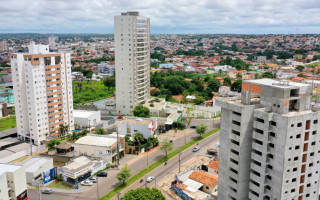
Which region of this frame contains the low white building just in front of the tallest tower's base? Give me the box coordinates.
[118,118,157,138]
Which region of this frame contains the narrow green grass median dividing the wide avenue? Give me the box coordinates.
[100,128,220,200]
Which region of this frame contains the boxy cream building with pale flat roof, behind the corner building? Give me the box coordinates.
[72,134,125,164]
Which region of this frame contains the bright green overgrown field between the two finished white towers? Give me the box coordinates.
[72,81,115,105]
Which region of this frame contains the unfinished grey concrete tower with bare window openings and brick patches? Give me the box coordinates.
[217,79,320,200]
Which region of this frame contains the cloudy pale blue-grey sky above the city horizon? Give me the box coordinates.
[0,0,320,34]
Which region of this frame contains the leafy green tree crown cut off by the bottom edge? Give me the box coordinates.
[120,187,166,200]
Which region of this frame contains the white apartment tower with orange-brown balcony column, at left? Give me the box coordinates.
[11,42,74,145]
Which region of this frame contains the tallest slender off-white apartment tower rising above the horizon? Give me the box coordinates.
[114,12,150,114]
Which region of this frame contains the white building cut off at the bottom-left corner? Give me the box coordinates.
[0,163,28,200]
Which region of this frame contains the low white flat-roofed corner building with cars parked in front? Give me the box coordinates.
[57,156,104,184]
